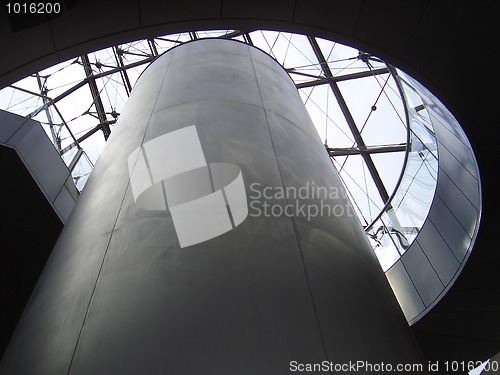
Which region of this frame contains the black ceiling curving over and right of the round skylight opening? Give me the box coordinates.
[0,0,500,366]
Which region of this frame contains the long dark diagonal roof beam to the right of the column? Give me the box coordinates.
[307,36,389,203]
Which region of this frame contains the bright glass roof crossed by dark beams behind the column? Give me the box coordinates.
[0,30,407,227]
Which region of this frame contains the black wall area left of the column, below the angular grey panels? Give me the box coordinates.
[0,146,63,354]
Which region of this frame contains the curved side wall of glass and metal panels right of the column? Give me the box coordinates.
[366,71,481,324]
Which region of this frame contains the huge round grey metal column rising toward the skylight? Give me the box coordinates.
[0,40,428,374]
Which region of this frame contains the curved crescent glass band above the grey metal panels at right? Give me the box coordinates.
[367,70,438,271]
